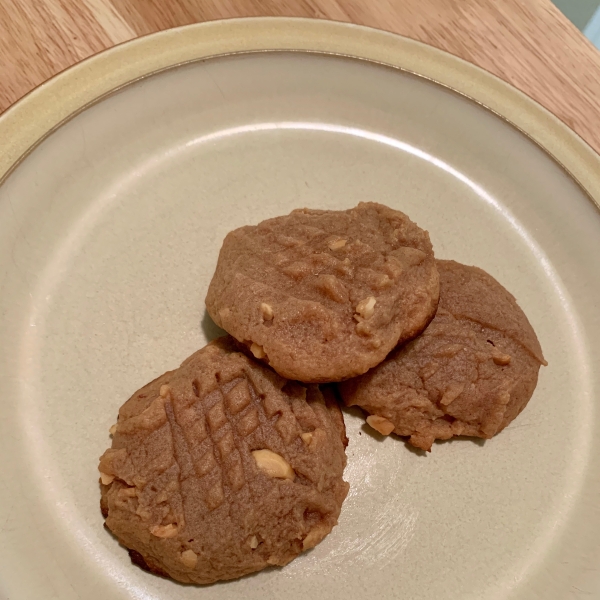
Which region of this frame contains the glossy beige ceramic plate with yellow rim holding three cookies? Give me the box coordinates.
[0,19,600,600]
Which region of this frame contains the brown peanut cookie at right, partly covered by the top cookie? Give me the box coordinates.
[339,260,546,450]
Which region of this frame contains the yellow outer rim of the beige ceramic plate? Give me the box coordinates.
[0,17,600,216]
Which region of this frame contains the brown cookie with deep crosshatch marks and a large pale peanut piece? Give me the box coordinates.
[99,338,348,584]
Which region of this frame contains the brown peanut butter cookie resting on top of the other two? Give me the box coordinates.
[206,202,439,382]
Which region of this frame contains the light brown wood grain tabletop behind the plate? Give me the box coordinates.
[0,0,600,151]
